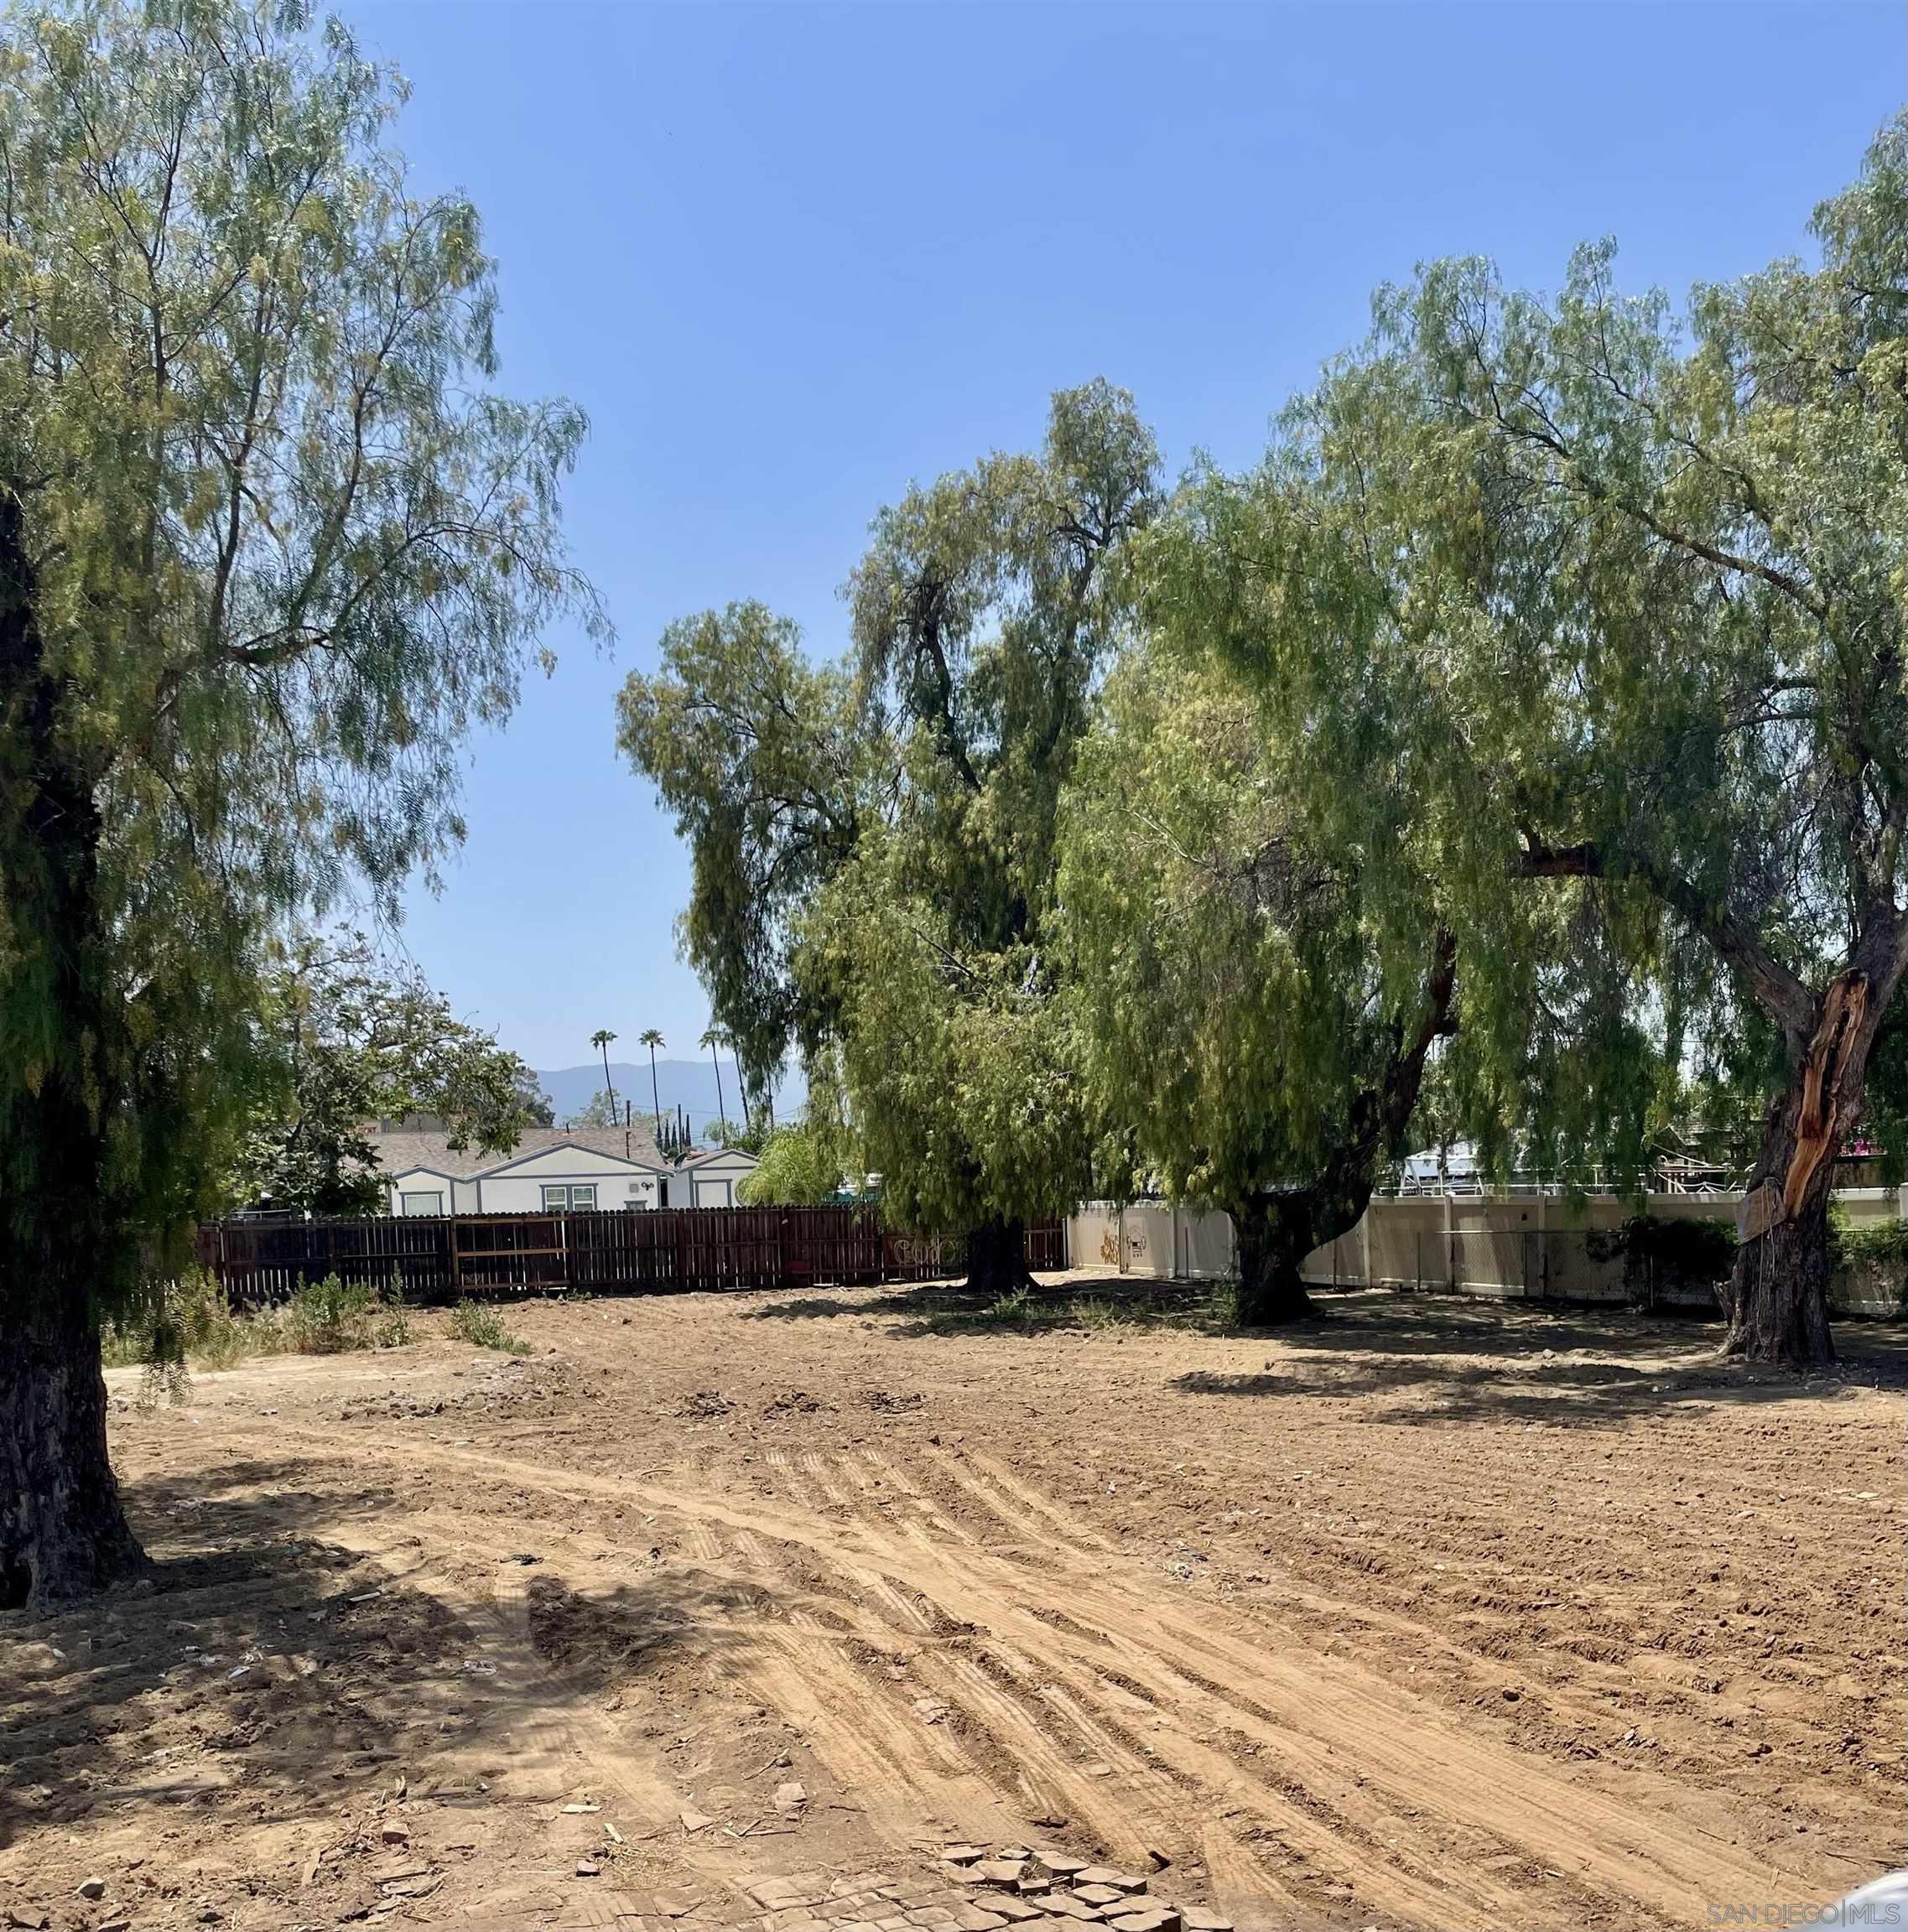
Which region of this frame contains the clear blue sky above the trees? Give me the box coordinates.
[342,0,1908,1067]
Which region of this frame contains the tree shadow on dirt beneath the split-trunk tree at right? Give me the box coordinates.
[1173,1291,1908,1424]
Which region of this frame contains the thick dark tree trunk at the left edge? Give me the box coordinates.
[0,491,139,1606]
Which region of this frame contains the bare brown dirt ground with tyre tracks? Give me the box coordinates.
[0,1277,1908,1932]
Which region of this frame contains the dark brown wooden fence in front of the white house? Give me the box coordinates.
[197,1208,1067,1304]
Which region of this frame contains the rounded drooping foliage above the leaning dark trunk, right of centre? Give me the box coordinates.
[1059,649,1438,1208]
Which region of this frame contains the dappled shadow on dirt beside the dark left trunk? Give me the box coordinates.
[0,1457,767,1870]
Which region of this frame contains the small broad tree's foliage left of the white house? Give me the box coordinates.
[234,933,549,1215]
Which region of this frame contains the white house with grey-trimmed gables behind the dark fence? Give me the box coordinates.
[372,1126,756,1215]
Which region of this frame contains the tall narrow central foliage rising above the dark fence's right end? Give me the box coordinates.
[798,382,1158,1228]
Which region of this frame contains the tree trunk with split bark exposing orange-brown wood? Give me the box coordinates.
[1723,964,1895,1368]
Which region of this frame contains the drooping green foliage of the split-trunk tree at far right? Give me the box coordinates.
[1142,120,1908,1173]
